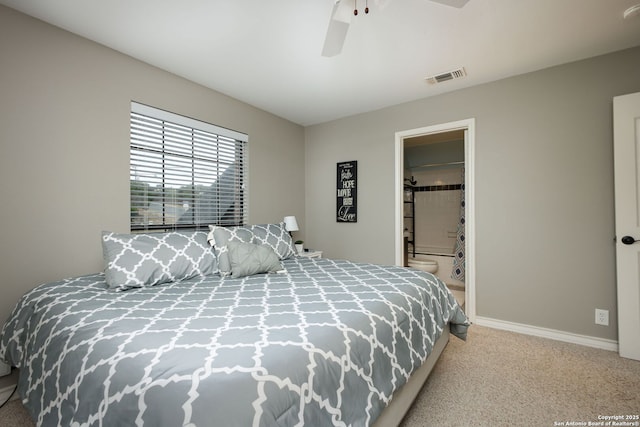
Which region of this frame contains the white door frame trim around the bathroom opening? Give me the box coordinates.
[395,118,476,322]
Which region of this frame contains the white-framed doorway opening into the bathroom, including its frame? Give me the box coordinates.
[395,119,475,322]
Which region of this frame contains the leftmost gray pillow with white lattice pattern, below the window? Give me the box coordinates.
[102,231,217,291]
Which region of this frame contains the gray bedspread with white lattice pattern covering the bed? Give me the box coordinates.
[0,258,468,427]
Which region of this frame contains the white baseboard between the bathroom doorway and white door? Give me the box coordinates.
[475,316,618,353]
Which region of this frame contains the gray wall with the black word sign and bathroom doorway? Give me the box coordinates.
[305,48,640,340]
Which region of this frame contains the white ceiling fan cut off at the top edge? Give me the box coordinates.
[322,0,469,57]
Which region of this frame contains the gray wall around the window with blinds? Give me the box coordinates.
[0,6,305,322]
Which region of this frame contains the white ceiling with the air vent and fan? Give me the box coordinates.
[0,0,640,125]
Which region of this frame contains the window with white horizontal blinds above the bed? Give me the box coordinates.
[129,102,248,231]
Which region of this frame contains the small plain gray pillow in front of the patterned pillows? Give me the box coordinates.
[227,240,284,278]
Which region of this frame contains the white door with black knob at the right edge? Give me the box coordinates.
[613,93,640,360]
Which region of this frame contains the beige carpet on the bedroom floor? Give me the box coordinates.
[0,325,640,427]
